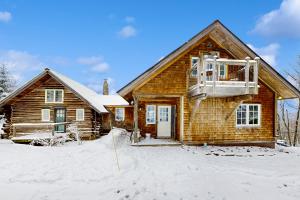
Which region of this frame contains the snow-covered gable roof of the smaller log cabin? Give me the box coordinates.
[0,68,128,113]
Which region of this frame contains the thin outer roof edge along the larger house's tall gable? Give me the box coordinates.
[117,19,300,98]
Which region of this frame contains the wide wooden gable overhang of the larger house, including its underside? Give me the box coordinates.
[118,20,300,99]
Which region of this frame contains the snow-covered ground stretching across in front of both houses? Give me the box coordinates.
[0,128,300,200]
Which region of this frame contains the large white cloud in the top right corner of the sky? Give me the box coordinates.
[253,0,300,37]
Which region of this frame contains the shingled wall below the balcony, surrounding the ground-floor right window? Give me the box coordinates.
[184,80,275,144]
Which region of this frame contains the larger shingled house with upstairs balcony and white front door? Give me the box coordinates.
[118,20,300,147]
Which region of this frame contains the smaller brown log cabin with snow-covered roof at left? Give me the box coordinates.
[0,69,128,139]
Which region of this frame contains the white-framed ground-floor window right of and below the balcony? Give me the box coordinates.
[236,104,260,127]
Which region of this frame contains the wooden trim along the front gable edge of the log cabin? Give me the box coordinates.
[0,68,107,113]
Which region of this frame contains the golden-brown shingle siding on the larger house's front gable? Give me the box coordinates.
[133,38,275,143]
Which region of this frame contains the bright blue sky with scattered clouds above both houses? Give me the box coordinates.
[0,0,300,94]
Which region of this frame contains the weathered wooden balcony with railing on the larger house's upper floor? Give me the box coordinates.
[188,56,259,98]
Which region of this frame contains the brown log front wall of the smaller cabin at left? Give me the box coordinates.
[11,78,93,136]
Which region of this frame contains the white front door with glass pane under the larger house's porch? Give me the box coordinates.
[157,106,171,138]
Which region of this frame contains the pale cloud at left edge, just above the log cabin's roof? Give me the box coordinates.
[0,50,46,83]
